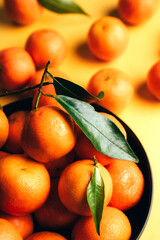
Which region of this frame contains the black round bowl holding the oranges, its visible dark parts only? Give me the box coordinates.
[3,99,153,240]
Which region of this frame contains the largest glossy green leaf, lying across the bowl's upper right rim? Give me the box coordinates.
[55,95,138,162]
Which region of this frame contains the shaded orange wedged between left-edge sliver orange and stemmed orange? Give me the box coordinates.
[4,111,28,153]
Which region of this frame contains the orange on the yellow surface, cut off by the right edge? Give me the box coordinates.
[147,61,160,100]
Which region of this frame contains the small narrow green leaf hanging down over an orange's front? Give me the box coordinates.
[87,166,104,235]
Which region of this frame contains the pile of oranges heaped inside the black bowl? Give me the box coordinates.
[0,90,144,240]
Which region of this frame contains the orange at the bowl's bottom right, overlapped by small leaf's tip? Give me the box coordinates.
[72,206,131,240]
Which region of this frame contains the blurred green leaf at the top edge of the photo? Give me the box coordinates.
[38,0,88,15]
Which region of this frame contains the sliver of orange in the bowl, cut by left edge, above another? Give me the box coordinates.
[0,109,9,148]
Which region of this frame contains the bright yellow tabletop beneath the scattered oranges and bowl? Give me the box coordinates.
[0,0,160,240]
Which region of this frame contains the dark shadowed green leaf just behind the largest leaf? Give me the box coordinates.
[47,72,104,103]
